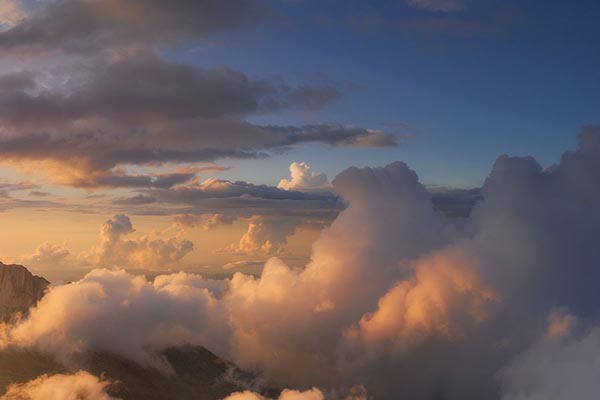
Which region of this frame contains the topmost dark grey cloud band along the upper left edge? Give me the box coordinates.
[0,0,266,54]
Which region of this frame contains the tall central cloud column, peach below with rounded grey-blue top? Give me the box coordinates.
[227,163,444,385]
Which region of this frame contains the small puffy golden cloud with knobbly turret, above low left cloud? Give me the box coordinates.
[80,214,194,269]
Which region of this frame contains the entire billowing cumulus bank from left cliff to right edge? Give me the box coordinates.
[0,127,600,400]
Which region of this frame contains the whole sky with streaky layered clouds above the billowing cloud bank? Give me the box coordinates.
[0,0,600,279]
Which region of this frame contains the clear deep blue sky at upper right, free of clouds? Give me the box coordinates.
[159,0,600,187]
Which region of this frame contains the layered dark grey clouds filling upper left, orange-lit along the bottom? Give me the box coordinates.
[0,0,398,191]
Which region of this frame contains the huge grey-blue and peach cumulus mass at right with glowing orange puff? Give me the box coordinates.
[227,127,600,399]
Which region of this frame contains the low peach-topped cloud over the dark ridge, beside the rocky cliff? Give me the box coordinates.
[0,269,227,367]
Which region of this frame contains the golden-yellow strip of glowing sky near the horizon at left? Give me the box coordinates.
[0,209,319,281]
